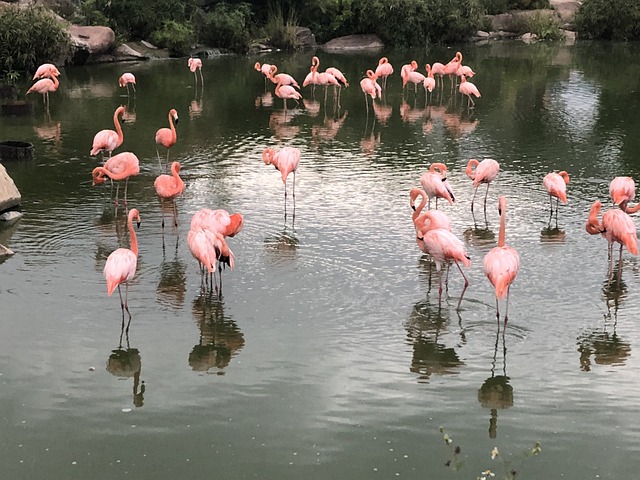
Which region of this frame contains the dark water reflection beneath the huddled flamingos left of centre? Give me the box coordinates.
[189,293,244,375]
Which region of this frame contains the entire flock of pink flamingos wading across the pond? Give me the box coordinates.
[27,52,640,324]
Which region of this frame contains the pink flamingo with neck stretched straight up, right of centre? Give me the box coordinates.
[484,196,520,324]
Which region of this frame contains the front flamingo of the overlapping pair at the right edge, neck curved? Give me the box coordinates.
[586,200,638,276]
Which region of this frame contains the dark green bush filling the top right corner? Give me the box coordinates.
[575,0,640,40]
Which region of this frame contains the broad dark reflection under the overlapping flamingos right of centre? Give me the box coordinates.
[406,301,464,383]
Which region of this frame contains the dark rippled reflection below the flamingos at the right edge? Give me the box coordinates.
[578,277,631,372]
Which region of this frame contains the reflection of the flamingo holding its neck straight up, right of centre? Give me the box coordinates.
[478,321,513,438]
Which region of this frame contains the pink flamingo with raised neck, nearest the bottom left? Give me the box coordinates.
[103,208,140,316]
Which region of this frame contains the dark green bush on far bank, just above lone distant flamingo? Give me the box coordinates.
[194,3,251,52]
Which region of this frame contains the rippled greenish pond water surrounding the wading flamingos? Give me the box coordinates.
[0,43,640,479]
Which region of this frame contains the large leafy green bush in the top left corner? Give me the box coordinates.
[0,6,71,77]
